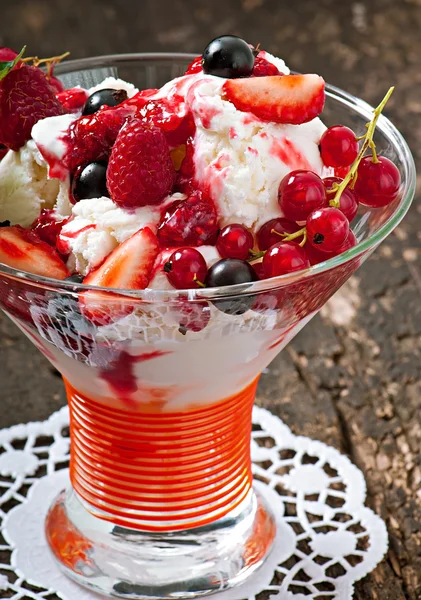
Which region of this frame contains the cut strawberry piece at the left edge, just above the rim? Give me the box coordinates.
[0,225,69,279]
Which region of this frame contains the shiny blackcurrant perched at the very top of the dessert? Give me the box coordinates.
[202,35,254,79]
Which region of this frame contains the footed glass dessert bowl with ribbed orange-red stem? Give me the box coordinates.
[0,48,415,599]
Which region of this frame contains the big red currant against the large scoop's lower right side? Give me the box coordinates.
[278,170,326,221]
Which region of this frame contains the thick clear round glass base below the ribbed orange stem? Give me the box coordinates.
[46,490,276,600]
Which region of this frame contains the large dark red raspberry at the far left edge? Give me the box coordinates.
[0,64,64,150]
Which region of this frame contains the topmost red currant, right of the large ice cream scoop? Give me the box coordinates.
[320,125,358,167]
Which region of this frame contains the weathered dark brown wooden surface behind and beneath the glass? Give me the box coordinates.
[0,0,421,600]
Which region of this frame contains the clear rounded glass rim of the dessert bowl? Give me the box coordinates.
[0,52,416,302]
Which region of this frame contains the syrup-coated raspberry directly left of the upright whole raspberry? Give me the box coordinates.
[65,106,133,173]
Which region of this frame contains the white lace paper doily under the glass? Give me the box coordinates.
[0,407,387,600]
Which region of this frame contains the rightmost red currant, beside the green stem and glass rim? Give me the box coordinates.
[354,155,401,208]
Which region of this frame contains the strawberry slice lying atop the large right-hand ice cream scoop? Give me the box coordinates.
[222,75,325,125]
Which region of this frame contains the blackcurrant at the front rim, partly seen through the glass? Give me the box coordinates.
[205,258,258,315]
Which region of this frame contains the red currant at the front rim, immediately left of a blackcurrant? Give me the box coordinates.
[164,248,208,290]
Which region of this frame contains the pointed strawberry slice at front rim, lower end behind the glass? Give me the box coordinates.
[79,227,159,325]
